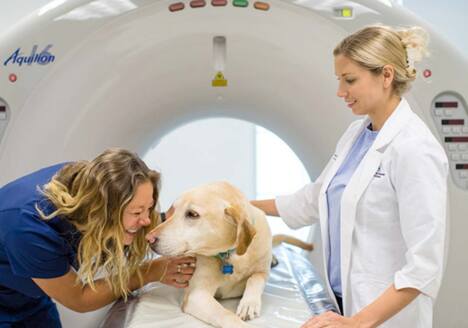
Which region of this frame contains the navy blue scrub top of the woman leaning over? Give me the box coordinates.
[0,164,81,323]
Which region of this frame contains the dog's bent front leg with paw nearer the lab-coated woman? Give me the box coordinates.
[236,273,267,320]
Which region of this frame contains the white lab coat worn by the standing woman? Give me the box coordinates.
[276,99,448,328]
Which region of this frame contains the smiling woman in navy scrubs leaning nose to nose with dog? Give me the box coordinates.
[0,149,195,328]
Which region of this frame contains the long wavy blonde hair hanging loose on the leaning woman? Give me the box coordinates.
[36,149,160,298]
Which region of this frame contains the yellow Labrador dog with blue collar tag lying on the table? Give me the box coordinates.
[146,182,272,328]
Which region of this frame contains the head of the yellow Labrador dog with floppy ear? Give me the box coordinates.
[148,182,255,256]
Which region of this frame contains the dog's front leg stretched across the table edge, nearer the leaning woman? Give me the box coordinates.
[182,289,251,328]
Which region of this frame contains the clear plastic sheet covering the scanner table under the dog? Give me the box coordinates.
[100,246,336,328]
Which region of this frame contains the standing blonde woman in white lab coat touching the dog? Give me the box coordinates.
[252,26,448,328]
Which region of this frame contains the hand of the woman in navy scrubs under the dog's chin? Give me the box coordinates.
[152,256,197,288]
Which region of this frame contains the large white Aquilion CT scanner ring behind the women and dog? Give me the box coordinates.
[0,0,468,327]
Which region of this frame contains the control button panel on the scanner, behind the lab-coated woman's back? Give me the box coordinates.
[431,92,468,190]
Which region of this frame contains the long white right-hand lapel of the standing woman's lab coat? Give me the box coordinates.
[341,98,412,310]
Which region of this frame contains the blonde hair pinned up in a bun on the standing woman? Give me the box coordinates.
[333,26,428,96]
